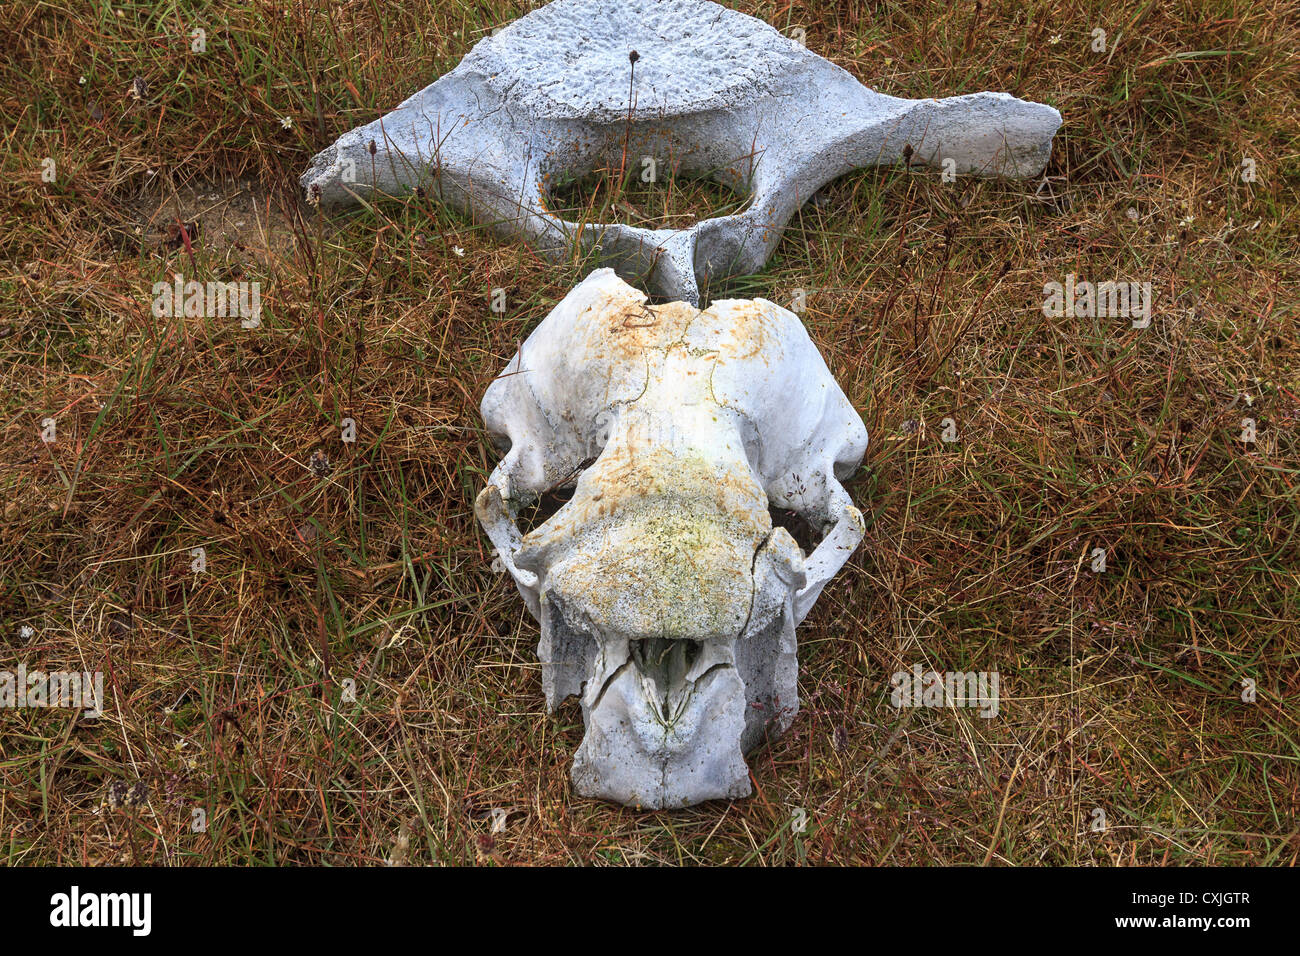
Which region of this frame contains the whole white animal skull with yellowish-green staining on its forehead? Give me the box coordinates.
[476,269,867,808]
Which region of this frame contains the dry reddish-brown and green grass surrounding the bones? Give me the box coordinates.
[0,0,1300,865]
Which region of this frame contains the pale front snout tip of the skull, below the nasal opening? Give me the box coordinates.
[573,641,750,809]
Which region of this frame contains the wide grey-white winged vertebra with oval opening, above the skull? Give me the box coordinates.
[302,0,1061,304]
